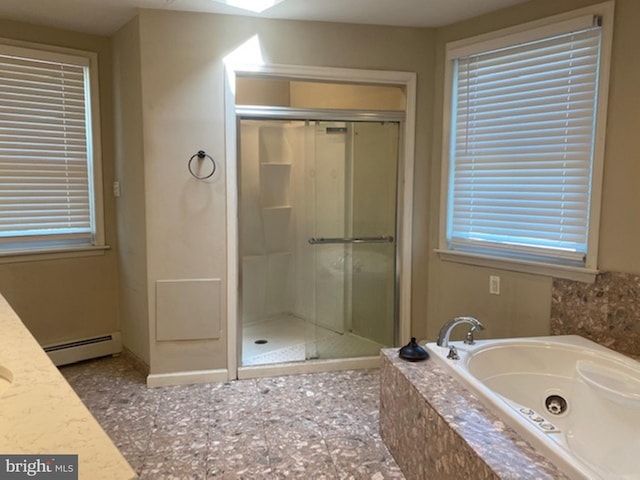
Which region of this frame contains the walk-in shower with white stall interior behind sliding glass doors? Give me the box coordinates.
[238,112,400,366]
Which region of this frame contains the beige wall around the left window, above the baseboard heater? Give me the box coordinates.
[0,20,119,345]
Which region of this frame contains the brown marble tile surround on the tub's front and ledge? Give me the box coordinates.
[380,349,567,480]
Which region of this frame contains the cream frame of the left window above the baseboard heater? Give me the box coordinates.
[0,38,110,264]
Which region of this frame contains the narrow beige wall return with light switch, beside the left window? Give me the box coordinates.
[113,17,149,365]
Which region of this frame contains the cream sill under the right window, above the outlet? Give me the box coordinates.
[435,249,598,283]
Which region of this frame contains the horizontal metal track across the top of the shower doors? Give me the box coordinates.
[236,105,405,122]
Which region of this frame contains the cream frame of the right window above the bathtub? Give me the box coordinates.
[435,1,614,282]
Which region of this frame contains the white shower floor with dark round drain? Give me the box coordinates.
[242,314,383,366]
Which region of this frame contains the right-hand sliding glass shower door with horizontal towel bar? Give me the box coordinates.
[306,122,398,359]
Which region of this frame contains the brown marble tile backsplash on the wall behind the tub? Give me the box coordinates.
[551,272,640,357]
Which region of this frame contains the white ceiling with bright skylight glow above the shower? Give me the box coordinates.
[0,0,527,35]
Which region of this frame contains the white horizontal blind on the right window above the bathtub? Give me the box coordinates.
[447,28,600,263]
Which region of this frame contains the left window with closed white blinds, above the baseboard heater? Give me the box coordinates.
[0,45,104,255]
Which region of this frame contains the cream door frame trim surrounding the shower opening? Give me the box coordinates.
[224,64,417,380]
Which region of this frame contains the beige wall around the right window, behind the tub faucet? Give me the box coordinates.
[418,0,640,339]
